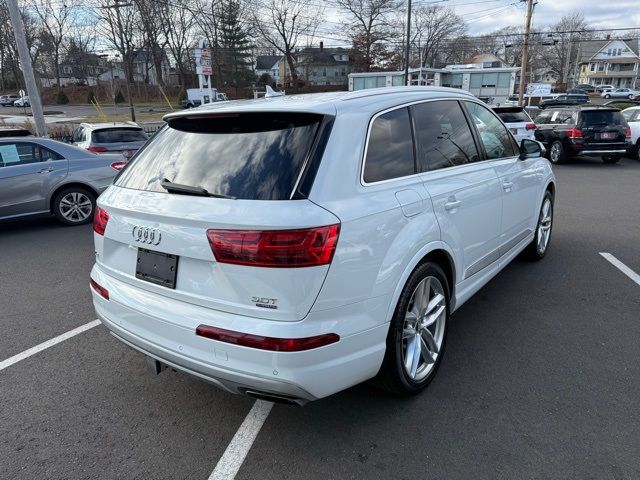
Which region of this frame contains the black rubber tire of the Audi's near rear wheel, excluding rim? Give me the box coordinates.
[373,262,451,395]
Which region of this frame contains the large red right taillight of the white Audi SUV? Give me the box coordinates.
[207,224,340,267]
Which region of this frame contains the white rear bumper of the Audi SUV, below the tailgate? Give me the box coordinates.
[91,267,388,403]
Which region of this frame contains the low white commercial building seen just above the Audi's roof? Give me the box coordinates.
[349,65,520,103]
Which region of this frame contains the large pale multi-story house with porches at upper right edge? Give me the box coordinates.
[578,37,640,88]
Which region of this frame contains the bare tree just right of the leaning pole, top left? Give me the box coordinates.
[32,0,76,91]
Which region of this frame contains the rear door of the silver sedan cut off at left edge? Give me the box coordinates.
[0,141,68,218]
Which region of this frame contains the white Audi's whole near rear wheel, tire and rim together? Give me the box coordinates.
[374,262,450,395]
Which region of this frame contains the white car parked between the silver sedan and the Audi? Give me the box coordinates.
[72,122,149,158]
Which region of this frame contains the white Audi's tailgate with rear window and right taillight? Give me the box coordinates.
[96,113,339,321]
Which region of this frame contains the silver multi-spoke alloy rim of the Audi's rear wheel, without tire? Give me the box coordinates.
[402,276,447,381]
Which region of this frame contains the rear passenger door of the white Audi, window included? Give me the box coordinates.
[411,100,502,281]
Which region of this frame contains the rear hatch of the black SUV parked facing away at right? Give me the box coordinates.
[579,109,629,150]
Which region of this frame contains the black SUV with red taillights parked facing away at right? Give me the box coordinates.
[535,107,631,163]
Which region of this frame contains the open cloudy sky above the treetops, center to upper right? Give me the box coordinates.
[318,0,640,43]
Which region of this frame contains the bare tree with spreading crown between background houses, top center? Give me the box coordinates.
[251,0,324,84]
